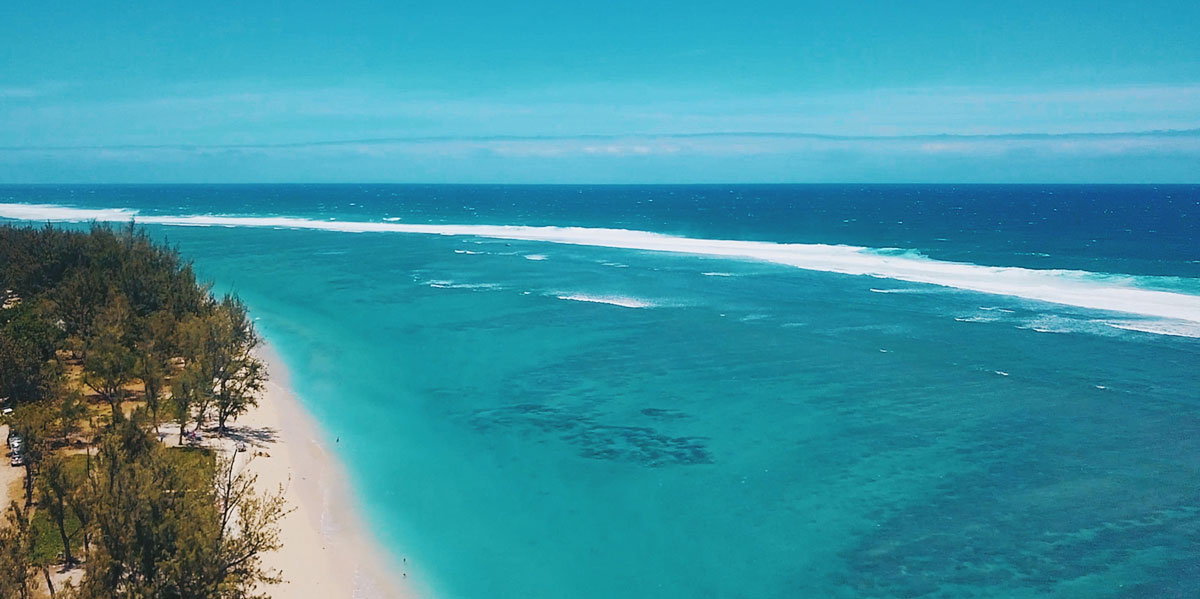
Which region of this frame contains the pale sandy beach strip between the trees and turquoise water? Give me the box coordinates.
[210,342,418,599]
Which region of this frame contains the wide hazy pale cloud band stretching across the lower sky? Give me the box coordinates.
[0,84,1200,151]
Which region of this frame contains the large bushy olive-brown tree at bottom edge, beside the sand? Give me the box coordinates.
[80,421,288,599]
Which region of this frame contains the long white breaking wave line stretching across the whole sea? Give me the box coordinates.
[0,203,1200,331]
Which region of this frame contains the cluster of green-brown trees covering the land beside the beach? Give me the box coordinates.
[0,223,288,599]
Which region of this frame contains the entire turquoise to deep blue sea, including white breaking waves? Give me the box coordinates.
[0,185,1200,599]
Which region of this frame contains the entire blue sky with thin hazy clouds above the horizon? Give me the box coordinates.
[0,0,1200,182]
